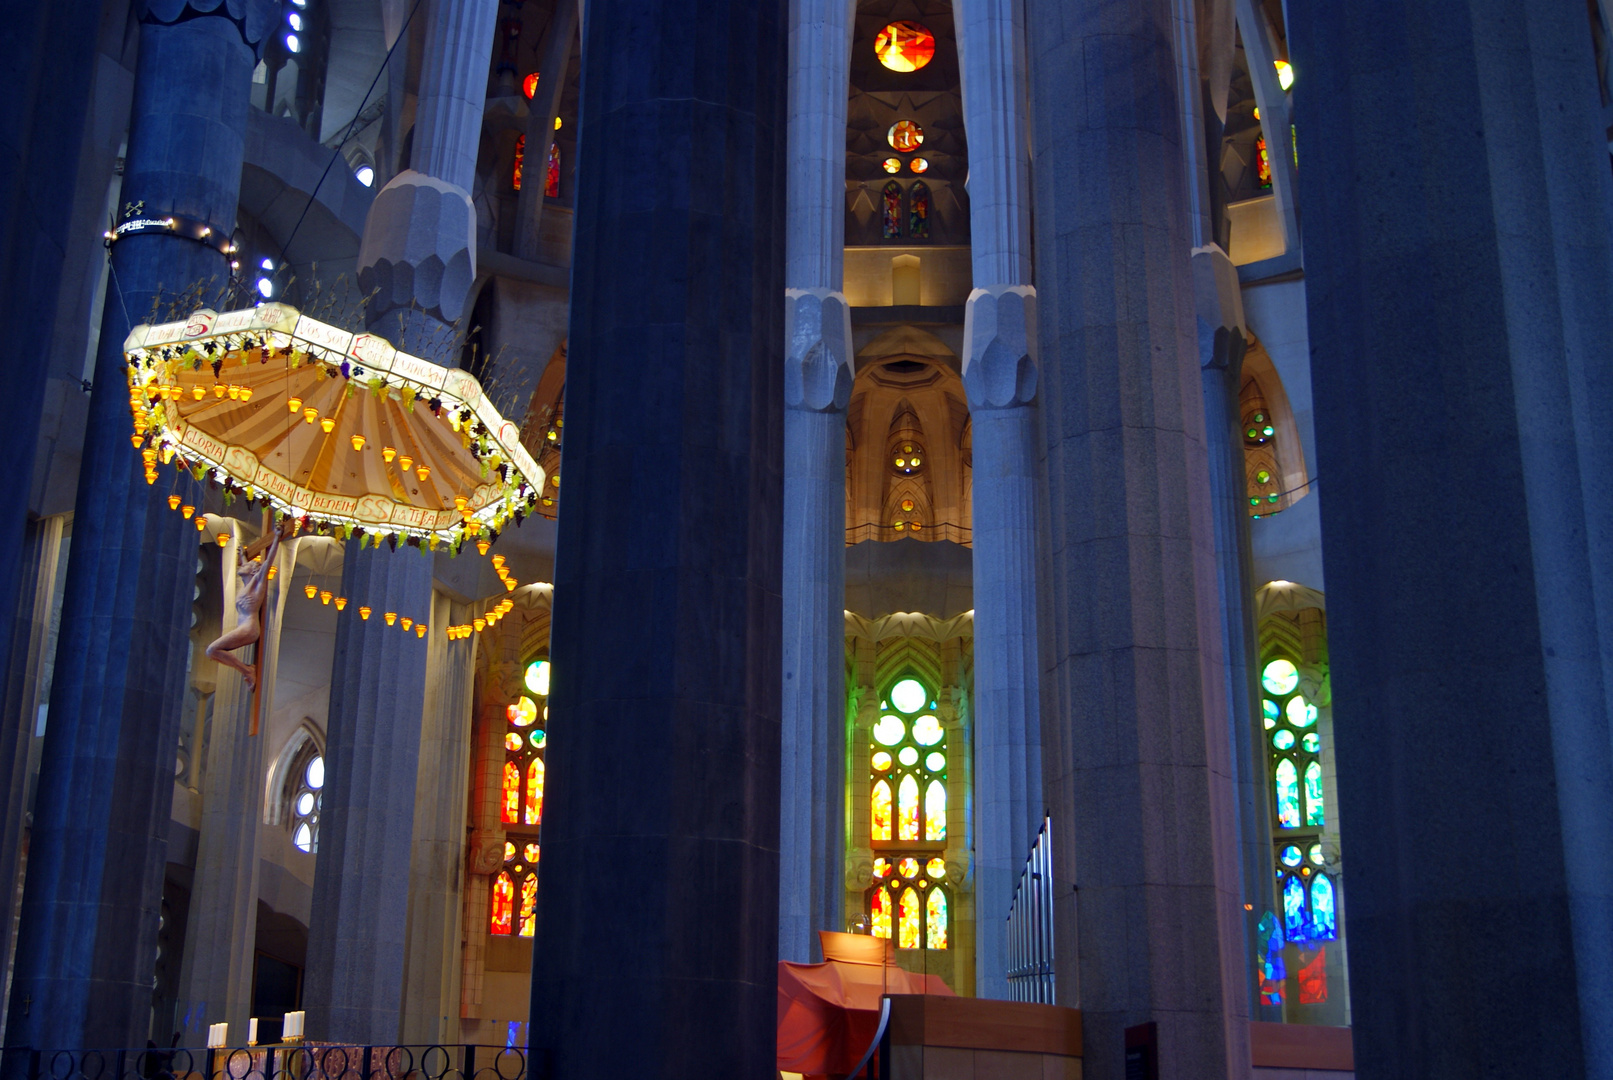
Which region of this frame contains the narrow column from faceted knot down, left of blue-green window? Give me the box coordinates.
[1194,245,1282,1020]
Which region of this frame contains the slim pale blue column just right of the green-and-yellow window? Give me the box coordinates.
[958,0,1047,998]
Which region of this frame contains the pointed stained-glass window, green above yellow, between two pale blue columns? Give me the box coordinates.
[866,674,952,949]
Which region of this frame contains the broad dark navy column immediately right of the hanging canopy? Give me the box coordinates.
[531,0,786,1080]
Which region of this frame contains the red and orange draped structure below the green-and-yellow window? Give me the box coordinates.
[779,930,952,1078]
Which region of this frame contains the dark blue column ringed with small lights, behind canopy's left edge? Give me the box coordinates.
[6,0,274,1046]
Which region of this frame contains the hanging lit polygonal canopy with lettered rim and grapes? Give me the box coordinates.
[124,303,544,551]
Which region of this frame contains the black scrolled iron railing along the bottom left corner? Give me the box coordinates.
[0,1043,545,1080]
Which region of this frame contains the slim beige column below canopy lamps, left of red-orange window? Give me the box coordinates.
[402,593,479,1045]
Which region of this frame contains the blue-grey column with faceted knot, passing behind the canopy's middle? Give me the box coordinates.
[306,0,498,1043]
